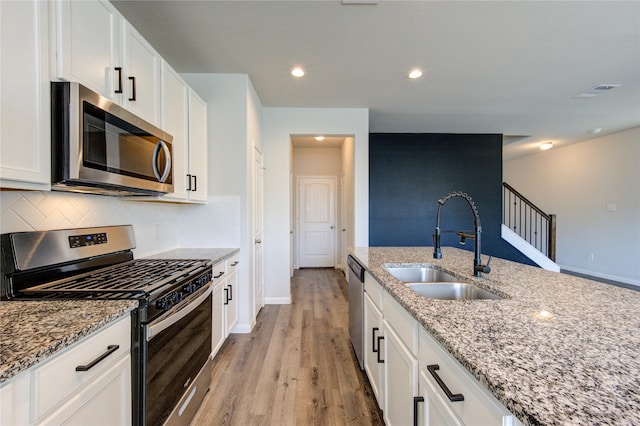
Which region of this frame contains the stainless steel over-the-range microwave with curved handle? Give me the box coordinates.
[51,82,173,195]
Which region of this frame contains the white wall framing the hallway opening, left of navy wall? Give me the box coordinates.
[262,107,369,303]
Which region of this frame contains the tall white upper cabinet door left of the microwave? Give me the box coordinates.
[0,0,51,190]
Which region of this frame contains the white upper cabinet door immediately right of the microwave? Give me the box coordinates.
[161,61,189,200]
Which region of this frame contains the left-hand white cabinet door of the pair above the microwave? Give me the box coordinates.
[52,0,124,103]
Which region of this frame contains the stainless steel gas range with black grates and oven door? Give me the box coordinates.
[1,225,212,425]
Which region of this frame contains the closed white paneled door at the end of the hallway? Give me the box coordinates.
[298,176,336,268]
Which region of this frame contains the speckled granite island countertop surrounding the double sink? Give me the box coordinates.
[351,247,640,425]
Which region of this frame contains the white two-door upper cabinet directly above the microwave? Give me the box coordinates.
[52,0,162,125]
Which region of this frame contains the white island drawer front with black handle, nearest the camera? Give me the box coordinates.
[420,330,518,425]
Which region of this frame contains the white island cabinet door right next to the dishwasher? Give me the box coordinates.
[364,293,385,407]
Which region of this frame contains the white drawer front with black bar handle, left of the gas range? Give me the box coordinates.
[31,316,131,420]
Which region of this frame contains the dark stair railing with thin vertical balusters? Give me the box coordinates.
[502,182,556,262]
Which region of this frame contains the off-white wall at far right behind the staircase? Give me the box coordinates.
[503,127,640,285]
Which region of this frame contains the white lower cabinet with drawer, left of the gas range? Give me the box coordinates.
[0,316,131,426]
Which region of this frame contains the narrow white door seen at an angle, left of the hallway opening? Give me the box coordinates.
[253,148,264,318]
